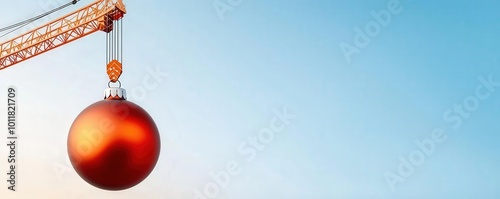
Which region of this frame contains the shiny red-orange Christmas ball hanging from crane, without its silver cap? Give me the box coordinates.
[68,99,160,190]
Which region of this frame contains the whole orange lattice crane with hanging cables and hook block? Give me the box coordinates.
[0,0,127,82]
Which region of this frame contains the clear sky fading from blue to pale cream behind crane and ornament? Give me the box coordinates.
[0,0,500,199]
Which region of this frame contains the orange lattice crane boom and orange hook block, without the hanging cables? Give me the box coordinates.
[0,0,127,71]
